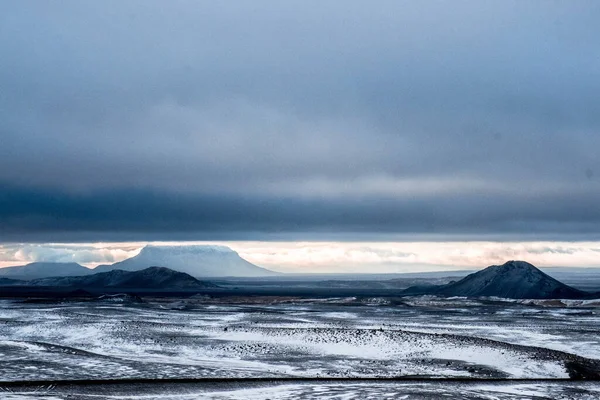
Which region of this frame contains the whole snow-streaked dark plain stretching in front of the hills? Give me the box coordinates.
[0,297,600,399]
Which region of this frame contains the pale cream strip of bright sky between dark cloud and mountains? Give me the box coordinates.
[0,241,600,273]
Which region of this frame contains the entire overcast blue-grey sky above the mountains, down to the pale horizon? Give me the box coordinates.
[0,0,600,268]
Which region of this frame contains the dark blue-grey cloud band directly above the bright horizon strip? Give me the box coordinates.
[0,183,600,242]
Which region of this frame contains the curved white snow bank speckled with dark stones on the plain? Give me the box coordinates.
[210,328,576,378]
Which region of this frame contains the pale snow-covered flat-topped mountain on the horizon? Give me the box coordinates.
[94,245,278,278]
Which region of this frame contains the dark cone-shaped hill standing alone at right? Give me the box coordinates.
[404,261,591,299]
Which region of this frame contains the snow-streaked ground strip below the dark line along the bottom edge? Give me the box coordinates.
[0,381,600,400]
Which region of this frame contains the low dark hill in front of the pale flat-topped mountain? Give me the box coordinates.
[27,267,216,290]
